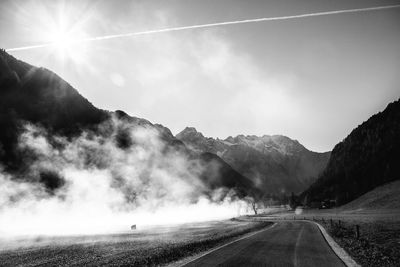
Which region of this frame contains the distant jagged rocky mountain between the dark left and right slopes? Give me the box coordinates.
[176,127,330,195]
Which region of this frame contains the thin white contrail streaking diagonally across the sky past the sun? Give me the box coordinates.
[6,5,400,52]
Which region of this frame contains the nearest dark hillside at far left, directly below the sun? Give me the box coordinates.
[0,50,109,169]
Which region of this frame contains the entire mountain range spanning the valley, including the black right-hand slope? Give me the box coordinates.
[0,47,400,205]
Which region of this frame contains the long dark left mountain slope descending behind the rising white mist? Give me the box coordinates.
[0,50,258,199]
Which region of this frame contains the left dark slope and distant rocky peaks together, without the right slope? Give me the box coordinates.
[0,50,329,200]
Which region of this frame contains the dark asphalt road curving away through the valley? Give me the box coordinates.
[185,221,345,267]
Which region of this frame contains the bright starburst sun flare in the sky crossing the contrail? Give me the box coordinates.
[9,1,95,65]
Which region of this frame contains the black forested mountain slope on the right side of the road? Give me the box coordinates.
[302,99,400,205]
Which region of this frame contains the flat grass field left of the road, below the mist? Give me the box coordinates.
[0,220,271,266]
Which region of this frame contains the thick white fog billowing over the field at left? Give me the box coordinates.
[0,117,249,237]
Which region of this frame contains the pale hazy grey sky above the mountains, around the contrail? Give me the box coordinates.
[0,0,400,152]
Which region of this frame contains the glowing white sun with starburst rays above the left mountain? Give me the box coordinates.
[7,0,95,72]
